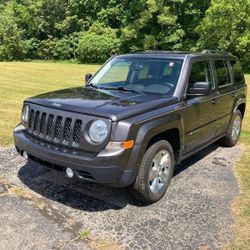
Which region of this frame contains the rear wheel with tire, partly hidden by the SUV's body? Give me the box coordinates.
[220,110,242,147]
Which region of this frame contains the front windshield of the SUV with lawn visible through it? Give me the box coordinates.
[91,57,182,95]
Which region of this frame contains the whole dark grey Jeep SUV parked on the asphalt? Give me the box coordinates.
[14,51,246,202]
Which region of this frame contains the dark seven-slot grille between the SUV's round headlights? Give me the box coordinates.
[28,109,83,147]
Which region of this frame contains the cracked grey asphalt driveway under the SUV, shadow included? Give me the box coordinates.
[0,145,243,250]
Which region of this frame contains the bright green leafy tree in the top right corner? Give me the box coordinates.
[197,0,250,65]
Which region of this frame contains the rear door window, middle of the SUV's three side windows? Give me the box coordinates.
[214,60,231,87]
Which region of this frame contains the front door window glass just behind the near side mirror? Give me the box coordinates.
[188,61,212,88]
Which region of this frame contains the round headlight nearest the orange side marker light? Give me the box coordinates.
[89,120,108,143]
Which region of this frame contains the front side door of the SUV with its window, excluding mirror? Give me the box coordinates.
[183,59,218,154]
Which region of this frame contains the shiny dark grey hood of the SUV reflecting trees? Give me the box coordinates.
[26,87,177,121]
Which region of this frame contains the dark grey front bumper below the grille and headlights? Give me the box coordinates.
[14,130,140,187]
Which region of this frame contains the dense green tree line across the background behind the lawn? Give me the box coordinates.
[0,0,250,65]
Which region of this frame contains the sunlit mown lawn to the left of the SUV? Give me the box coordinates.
[0,61,99,146]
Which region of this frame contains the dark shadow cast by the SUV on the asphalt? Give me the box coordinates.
[18,144,218,212]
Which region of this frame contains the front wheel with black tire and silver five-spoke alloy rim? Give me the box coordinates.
[131,140,174,203]
